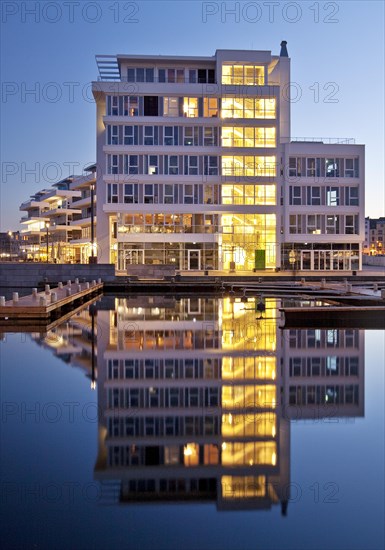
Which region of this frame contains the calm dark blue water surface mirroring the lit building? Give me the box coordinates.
[0,296,385,550]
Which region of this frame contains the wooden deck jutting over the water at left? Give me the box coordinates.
[0,283,103,324]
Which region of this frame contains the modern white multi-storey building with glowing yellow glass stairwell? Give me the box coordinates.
[93,42,364,272]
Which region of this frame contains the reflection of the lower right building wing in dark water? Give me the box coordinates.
[282,329,364,419]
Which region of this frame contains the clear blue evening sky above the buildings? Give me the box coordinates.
[0,0,385,231]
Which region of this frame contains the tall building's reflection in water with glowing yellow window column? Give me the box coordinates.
[95,297,289,513]
